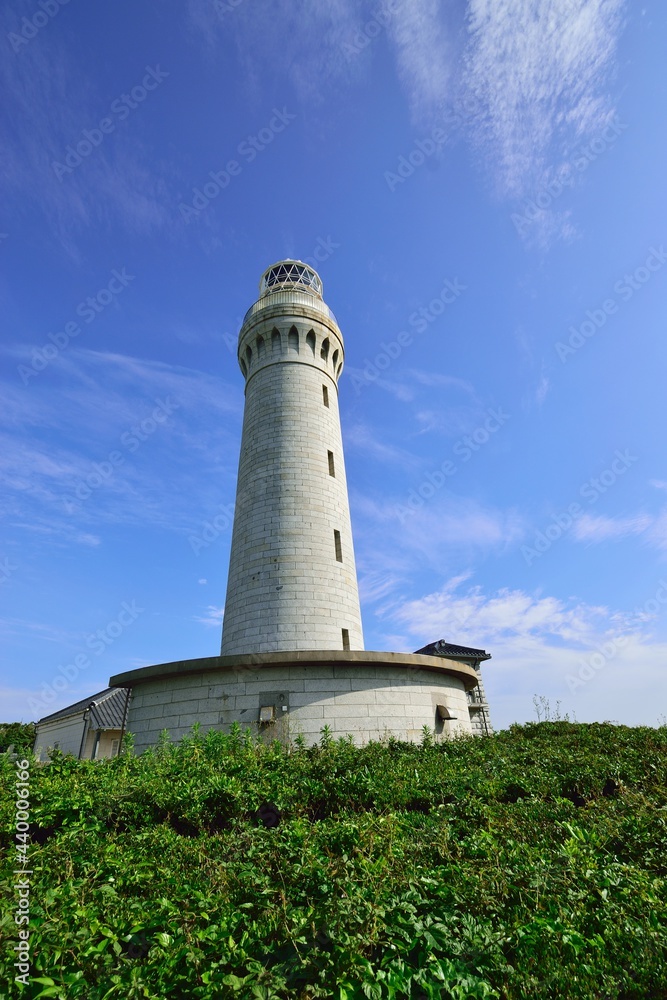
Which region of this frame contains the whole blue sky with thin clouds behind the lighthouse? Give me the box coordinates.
[0,0,667,728]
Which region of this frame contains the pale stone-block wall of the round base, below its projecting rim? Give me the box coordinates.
[127,664,471,753]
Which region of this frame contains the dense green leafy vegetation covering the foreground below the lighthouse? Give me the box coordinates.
[0,722,667,1000]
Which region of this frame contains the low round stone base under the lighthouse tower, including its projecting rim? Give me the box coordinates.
[109,650,477,753]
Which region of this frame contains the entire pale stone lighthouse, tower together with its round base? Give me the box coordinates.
[110,260,490,752]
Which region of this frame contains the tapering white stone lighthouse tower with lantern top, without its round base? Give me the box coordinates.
[221,260,364,656]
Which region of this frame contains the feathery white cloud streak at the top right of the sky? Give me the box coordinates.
[465,0,626,198]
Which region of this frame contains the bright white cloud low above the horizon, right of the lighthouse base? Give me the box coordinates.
[378,577,667,727]
